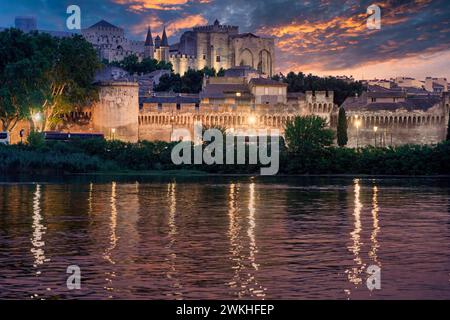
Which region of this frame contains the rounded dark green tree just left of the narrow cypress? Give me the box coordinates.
[285,116,334,155]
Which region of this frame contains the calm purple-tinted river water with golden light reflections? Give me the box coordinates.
[0,177,450,299]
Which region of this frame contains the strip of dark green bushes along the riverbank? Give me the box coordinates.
[0,135,450,175]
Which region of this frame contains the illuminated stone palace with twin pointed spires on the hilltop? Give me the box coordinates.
[82,20,275,76]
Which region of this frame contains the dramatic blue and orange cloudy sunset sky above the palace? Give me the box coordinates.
[0,0,450,79]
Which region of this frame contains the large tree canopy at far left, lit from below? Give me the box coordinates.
[0,29,100,131]
